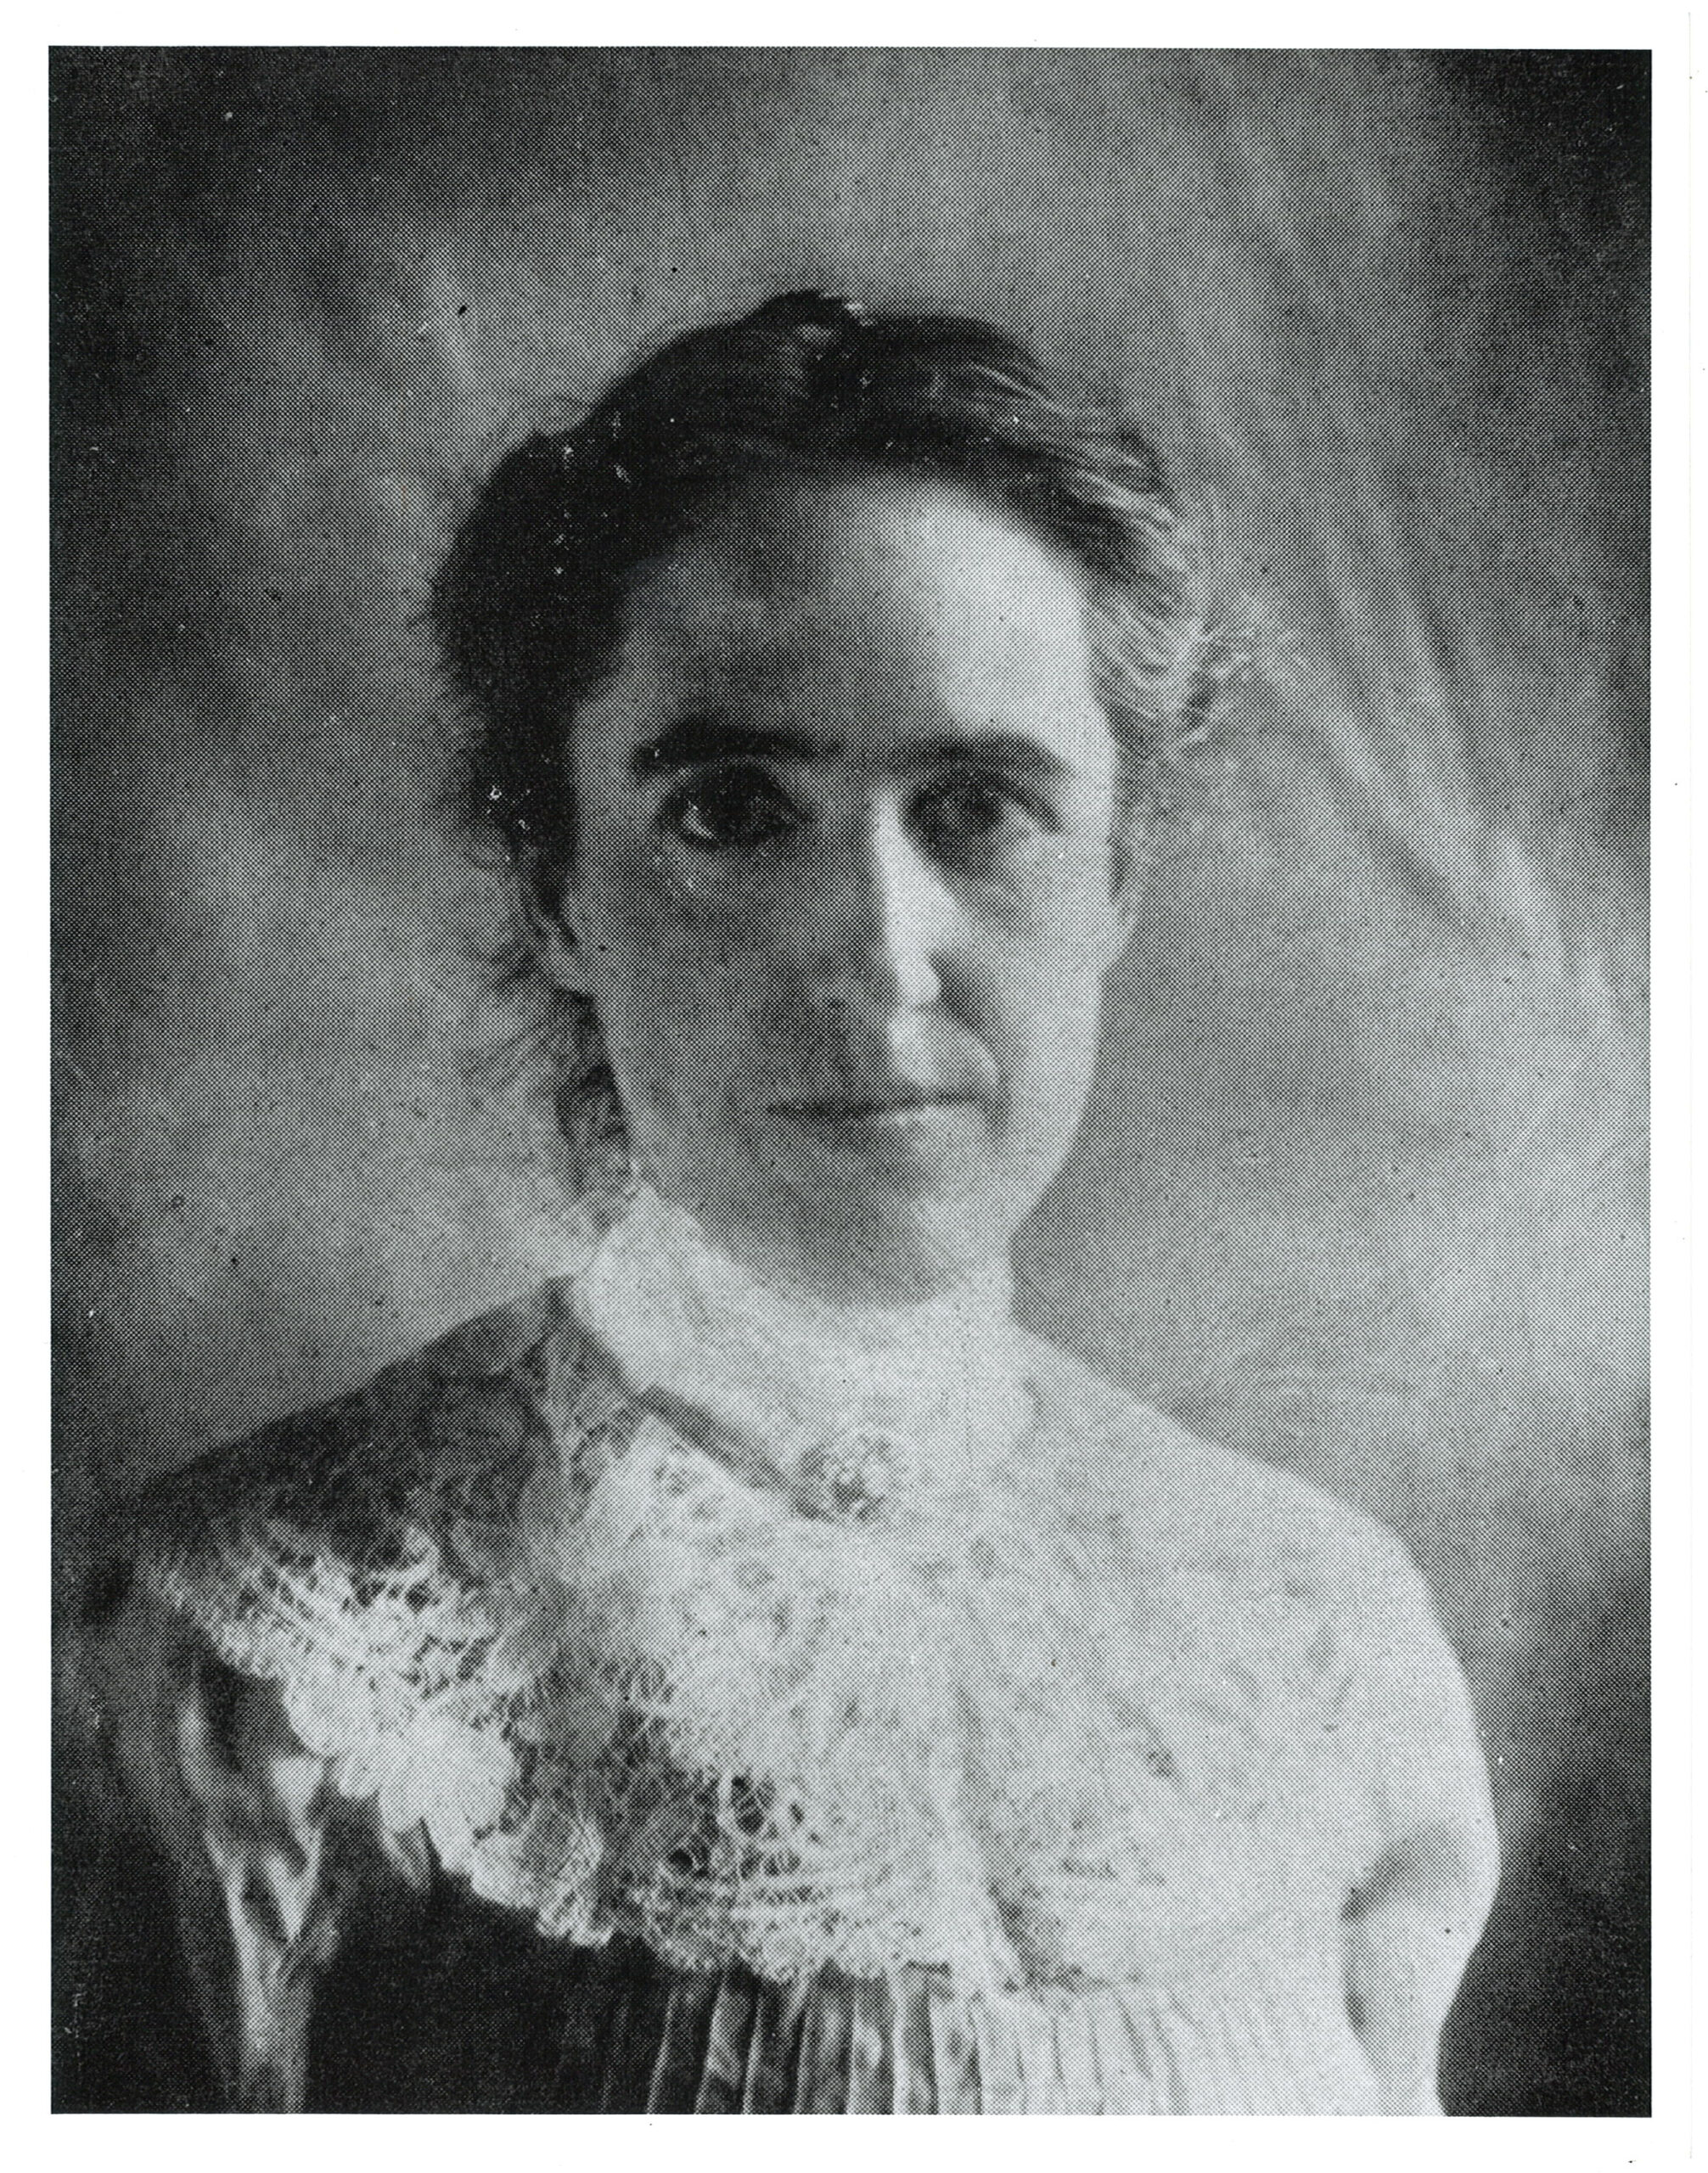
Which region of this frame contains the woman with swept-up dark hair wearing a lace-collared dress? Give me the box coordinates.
[66,295,1493,2112]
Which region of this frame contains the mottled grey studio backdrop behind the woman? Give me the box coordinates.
[54,50,1647,2112]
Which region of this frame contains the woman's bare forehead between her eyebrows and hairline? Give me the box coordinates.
[610,480,1106,752]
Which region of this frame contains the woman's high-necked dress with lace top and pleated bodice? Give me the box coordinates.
[70,1195,1491,2112]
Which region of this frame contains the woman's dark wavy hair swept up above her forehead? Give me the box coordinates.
[432,294,1206,884]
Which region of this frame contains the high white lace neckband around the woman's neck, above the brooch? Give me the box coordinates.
[571,1188,1032,1514]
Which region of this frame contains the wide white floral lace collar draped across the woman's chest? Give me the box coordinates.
[132,1199,1364,1988]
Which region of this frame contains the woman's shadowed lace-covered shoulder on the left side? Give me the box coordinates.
[82,1284,612,1712]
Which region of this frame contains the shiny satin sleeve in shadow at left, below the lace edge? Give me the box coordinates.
[71,1586,389,2112]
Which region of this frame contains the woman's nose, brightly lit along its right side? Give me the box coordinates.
[819,804,958,1015]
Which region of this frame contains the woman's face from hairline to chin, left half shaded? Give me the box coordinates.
[548,480,1126,1304]
